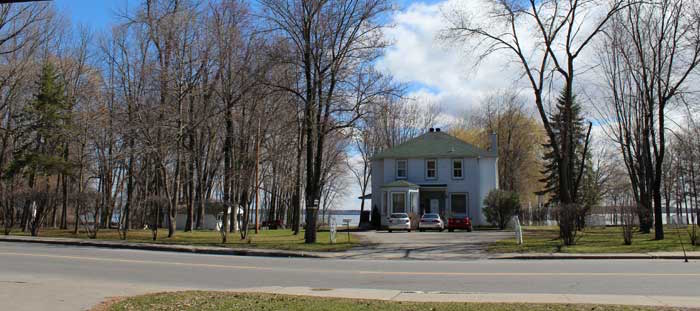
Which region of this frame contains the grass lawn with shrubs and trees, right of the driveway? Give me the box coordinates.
[488,227,700,253]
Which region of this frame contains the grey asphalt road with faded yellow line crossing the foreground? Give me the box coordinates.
[0,243,700,310]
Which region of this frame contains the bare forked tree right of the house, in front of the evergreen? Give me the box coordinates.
[443,0,627,244]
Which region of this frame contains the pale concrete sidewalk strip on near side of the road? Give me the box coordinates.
[233,286,700,308]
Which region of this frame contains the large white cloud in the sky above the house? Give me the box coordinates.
[378,1,532,117]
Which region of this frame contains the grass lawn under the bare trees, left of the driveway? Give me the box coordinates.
[11,229,359,251]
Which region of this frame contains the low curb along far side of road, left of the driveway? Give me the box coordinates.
[0,236,328,258]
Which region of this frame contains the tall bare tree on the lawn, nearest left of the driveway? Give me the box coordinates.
[261,0,391,243]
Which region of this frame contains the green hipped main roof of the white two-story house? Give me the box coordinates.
[372,131,495,160]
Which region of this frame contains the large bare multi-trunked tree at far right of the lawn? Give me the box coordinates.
[601,0,700,240]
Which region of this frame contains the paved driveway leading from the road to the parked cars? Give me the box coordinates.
[345,230,515,260]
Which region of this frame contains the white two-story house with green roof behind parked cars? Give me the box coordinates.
[372,128,498,226]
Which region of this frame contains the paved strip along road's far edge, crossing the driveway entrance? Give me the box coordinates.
[0,235,700,261]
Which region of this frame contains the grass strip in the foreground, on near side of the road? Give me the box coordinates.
[96,292,671,311]
